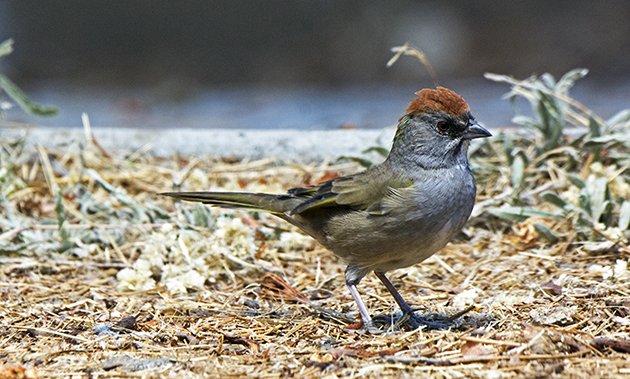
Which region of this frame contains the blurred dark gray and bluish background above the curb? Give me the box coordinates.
[0,0,630,129]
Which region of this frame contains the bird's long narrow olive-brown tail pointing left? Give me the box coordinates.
[160,192,300,214]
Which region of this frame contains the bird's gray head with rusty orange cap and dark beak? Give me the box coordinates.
[390,87,491,168]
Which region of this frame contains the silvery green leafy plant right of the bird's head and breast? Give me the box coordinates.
[486,69,630,241]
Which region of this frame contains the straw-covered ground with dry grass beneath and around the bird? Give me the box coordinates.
[0,122,630,378]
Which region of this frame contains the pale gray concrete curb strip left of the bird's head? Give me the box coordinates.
[0,127,394,162]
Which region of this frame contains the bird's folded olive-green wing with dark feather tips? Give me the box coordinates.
[289,166,413,216]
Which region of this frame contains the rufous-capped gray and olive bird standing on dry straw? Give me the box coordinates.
[162,86,491,330]
